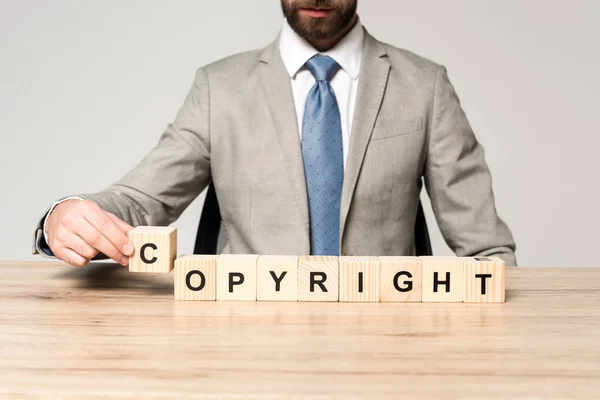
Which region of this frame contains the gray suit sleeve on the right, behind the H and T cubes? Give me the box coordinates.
[424,67,517,266]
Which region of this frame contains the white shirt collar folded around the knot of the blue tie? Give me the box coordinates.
[279,16,365,80]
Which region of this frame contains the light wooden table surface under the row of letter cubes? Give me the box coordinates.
[0,262,600,399]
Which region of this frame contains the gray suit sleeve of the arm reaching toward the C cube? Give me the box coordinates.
[34,68,211,254]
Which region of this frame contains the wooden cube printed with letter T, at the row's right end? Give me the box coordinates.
[463,257,506,303]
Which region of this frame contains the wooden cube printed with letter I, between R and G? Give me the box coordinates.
[339,257,380,303]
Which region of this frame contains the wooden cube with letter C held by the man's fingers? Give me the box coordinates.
[129,226,177,273]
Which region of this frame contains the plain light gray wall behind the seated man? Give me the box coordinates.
[0,0,600,266]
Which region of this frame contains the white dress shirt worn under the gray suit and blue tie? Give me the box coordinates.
[279,20,364,167]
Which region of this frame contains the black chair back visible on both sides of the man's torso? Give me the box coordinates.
[194,183,432,256]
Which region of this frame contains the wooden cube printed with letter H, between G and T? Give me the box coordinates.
[420,257,465,303]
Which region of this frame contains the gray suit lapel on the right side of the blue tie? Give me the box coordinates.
[340,30,390,241]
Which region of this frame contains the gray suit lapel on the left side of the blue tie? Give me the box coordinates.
[260,38,310,237]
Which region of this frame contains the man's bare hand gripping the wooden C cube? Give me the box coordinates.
[46,200,133,267]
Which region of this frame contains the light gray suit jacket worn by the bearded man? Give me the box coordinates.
[35,28,516,265]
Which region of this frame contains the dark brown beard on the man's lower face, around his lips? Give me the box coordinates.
[281,0,358,41]
